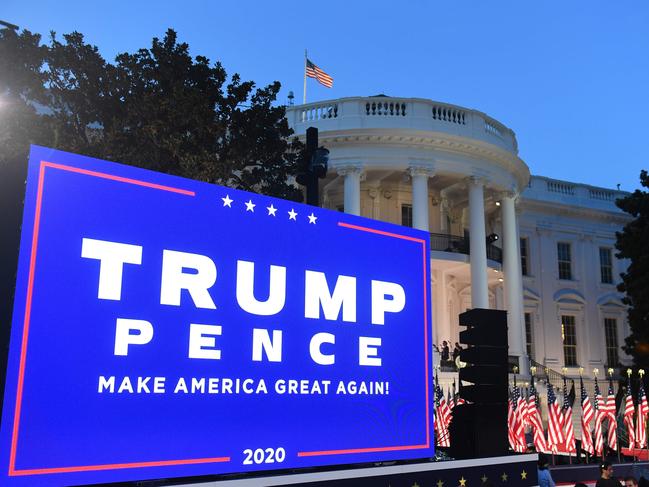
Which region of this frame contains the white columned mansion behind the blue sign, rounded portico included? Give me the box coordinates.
[287,95,630,386]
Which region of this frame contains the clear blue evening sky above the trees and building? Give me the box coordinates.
[5,0,649,191]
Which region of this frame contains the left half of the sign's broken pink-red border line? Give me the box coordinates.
[9,161,230,476]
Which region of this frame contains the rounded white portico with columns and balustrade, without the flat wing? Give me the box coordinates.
[287,96,530,369]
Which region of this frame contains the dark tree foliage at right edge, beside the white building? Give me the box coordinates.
[615,171,649,369]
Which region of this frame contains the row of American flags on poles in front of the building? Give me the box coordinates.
[434,378,649,457]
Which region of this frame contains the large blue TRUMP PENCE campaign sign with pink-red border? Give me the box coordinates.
[0,147,434,486]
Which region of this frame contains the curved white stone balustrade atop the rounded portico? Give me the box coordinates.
[286,96,518,154]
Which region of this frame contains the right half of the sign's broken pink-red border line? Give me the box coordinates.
[297,222,430,457]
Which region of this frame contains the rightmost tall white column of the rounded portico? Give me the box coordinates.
[500,193,529,374]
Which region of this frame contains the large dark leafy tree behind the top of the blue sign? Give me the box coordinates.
[0,29,302,200]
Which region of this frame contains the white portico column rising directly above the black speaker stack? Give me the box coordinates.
[469,178,489,309]
